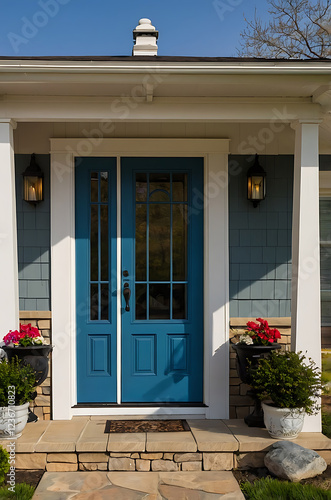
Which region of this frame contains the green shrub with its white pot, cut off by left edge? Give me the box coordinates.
[0,358,36,439]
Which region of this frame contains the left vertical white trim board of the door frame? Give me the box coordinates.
[51,152,76,420]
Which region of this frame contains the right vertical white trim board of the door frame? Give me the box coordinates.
[204,153,229,419]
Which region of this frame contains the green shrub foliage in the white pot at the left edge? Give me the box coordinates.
[0,356,36,406]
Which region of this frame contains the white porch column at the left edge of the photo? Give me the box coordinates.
[0,118,19,334]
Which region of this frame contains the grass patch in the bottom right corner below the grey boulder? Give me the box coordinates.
[240,478,331,500]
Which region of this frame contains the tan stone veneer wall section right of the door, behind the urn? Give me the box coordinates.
[230,318,291,418]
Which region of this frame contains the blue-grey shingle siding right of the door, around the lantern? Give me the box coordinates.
[229,155,294,318]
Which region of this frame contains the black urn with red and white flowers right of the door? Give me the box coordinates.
[232,318,281,427]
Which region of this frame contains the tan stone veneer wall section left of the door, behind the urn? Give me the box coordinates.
[20,311,52,420]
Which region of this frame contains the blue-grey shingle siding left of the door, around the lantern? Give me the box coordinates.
[15,154,51,311]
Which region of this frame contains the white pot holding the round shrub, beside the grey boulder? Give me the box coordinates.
[262,403,305,439]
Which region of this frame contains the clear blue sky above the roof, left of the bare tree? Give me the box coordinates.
[0,0,268,56]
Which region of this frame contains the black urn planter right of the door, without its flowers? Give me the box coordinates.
[232,343,280,427]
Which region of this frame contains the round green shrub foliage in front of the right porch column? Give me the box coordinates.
[250,352,323,415]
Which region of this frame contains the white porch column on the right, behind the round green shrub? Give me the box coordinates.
[291,122,321,432]
